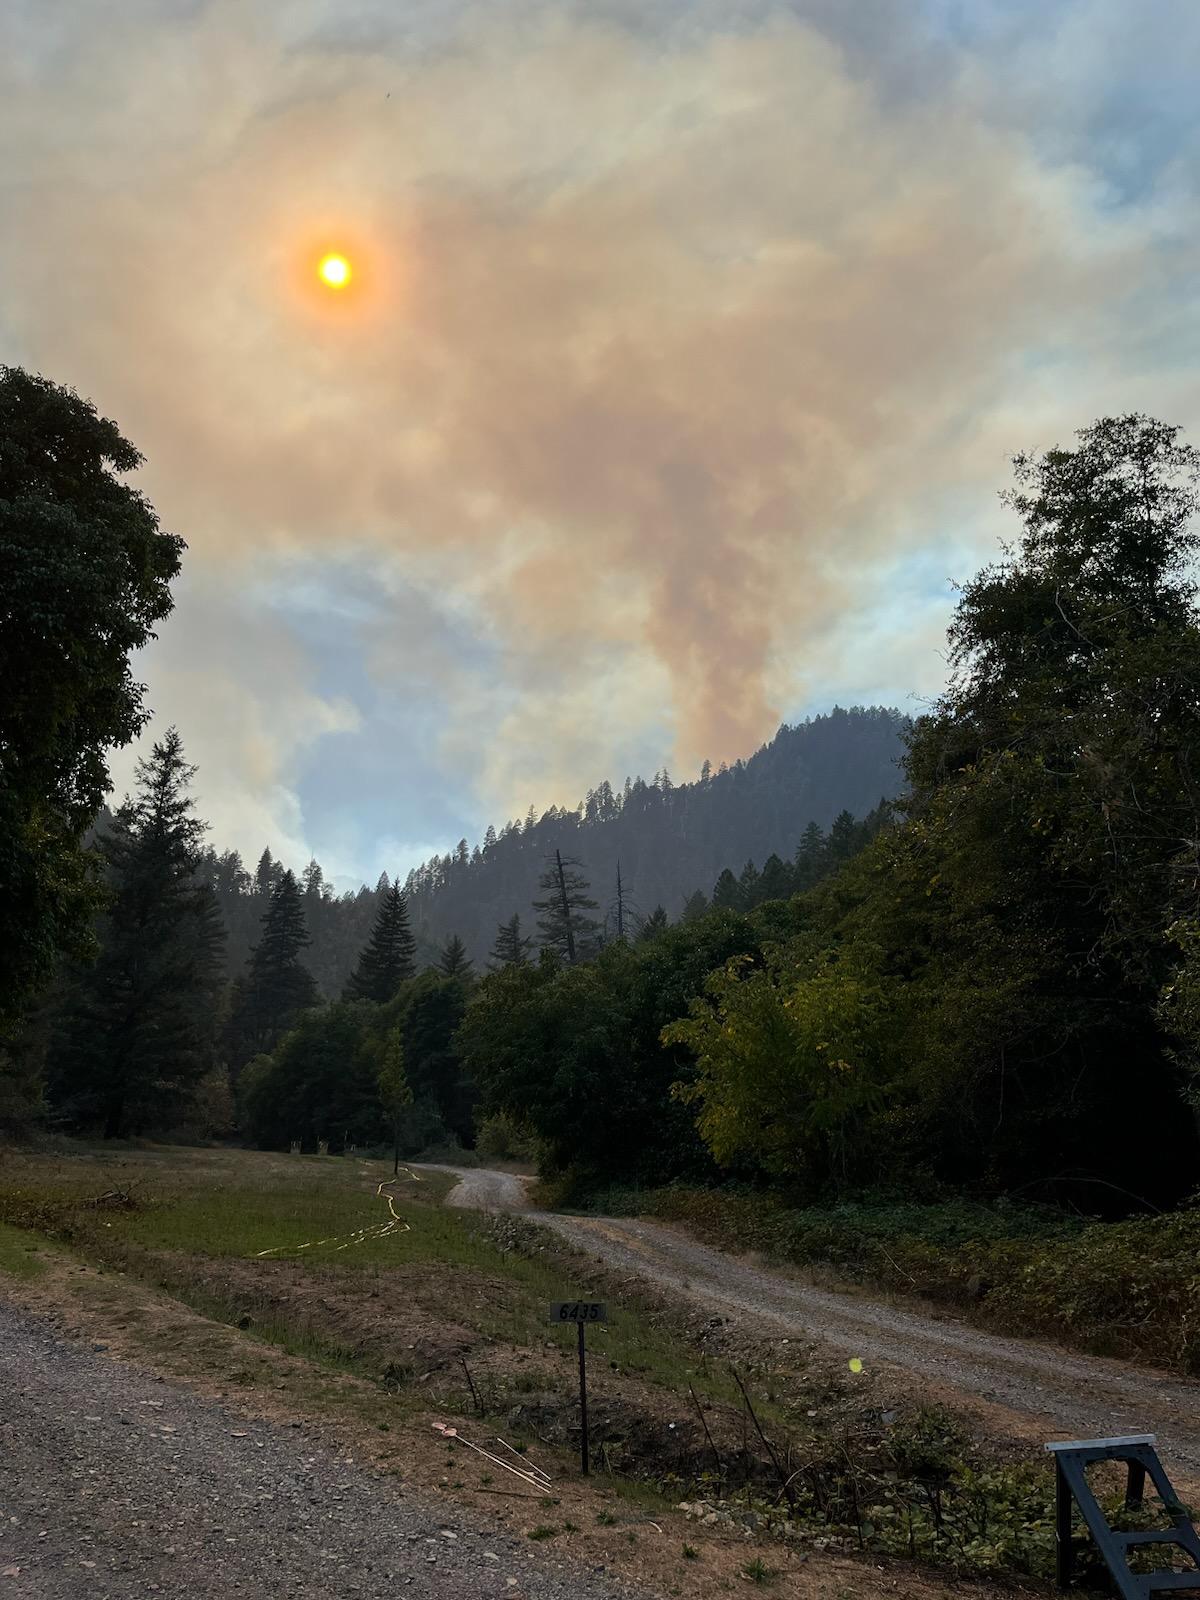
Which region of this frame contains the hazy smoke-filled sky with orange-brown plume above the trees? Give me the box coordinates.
[0,0,1200,882]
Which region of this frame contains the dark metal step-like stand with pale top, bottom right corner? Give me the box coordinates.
[1046,1434,1200,1600]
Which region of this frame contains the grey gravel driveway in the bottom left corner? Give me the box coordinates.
[0,1301,648,1600]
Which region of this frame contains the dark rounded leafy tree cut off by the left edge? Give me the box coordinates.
[0,366,184,1034]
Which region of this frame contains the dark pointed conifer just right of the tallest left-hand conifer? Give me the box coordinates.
[229,870,317,1067]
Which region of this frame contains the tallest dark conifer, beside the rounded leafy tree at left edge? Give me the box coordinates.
[51,728,224,1139]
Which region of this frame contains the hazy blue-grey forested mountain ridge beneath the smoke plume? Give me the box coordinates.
[203,707,906,979]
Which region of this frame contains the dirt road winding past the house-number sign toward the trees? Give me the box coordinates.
[438,1168,1200,1480]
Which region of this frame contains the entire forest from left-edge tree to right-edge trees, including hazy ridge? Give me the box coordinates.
[0,370,1200,1213]
